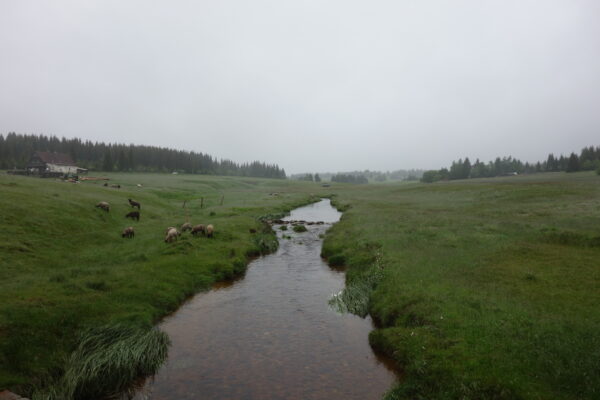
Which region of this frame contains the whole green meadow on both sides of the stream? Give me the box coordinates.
[0,173,600,400]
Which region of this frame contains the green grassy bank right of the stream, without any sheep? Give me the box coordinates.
[323,173,600,399]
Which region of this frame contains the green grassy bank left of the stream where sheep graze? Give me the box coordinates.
[0,173,318,397]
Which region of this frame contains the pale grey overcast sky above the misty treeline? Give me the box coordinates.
[0,0,600,173]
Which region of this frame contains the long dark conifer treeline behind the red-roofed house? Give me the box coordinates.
[0,133,286,179]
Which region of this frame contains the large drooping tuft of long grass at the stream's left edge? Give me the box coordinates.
[33,324,170,400]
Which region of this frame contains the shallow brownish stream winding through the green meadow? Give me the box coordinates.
[138,200,395,400]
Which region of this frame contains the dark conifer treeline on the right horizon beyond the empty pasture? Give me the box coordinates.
[421,146,600,182]
